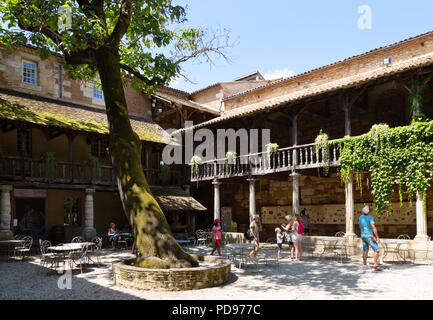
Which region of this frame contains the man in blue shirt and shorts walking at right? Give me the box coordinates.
[359,206,383,271]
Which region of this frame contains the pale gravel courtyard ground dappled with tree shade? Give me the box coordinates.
[0,248,433,300]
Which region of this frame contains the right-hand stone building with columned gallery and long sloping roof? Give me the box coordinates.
[177,32,433,248]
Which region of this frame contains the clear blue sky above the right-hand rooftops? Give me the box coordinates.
[171,0,433,92]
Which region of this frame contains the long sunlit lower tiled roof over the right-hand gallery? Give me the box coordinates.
[174,52,433,133]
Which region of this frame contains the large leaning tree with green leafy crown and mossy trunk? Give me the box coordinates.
[0,0,228,268]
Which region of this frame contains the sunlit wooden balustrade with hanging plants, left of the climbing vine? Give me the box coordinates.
[190,144,341,181]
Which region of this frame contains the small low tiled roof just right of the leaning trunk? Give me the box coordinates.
[150,186,207,211]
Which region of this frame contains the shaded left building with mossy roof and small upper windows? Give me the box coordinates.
[0,46,213,241]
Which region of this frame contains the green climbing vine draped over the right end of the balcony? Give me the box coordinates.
[330,121,433,214]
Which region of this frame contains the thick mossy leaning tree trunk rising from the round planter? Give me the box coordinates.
[96,47,198,268]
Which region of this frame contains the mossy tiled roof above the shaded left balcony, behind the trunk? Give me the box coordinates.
[0,89,170,144]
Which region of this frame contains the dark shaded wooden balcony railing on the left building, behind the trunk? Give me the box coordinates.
[0,156,185,187]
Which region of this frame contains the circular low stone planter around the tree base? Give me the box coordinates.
[113,256,231,291]
